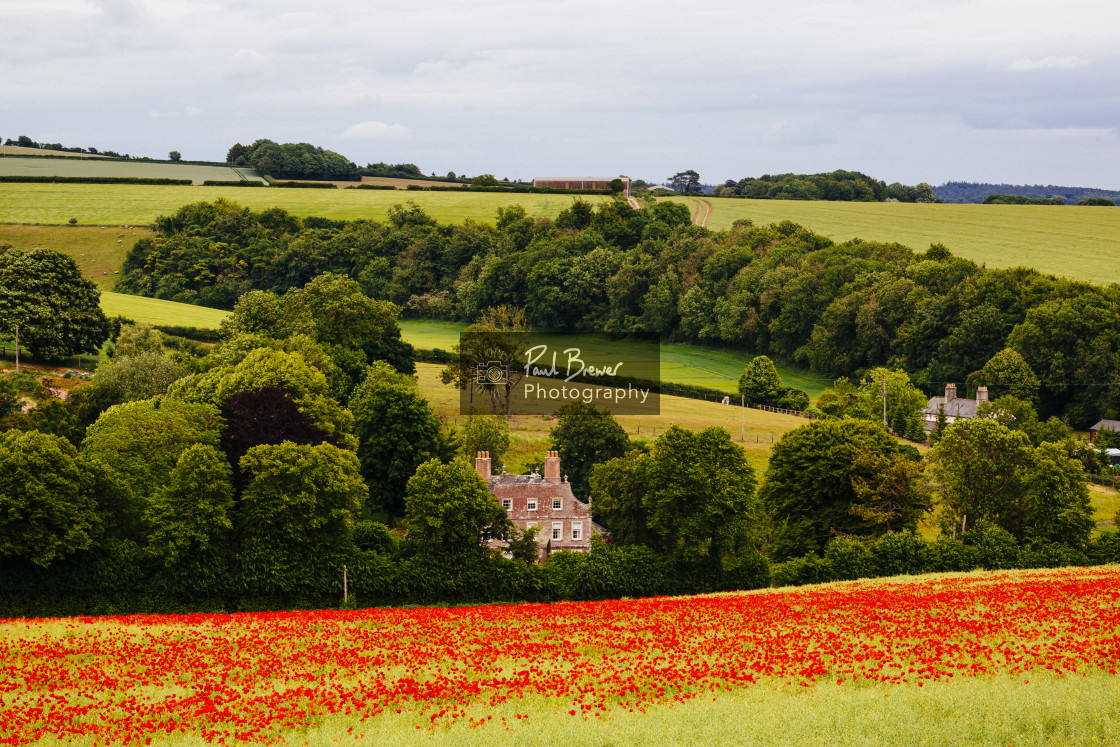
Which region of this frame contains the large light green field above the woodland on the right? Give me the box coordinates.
[669,197,1120,284]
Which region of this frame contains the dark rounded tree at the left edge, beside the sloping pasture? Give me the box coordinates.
[0,249,109,360]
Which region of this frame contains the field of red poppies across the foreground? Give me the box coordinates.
[0,567,1120,745]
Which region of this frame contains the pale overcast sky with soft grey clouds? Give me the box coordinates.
[0,0,1120,189]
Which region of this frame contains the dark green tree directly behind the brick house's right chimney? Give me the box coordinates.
[550,402,632,503]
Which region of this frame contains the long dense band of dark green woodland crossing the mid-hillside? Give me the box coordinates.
[118,199,1120,428]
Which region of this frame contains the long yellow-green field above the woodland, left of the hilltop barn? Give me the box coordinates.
[0,182,606,225]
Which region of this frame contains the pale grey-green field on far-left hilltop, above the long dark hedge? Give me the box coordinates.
[0,158,263,185]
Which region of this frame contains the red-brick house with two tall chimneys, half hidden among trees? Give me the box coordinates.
[475,451,599,560]
